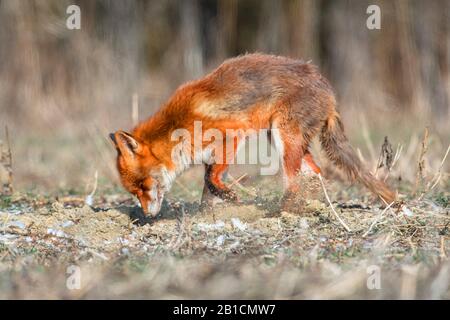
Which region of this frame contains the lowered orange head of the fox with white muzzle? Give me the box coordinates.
[110,131,165,216]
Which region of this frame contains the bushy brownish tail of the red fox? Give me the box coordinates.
[320,112,395,204]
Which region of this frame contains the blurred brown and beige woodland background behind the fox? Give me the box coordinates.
[0,0,450,191]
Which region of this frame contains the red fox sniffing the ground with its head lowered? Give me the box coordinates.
[110,54,395,216]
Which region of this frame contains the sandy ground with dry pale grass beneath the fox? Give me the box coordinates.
[0,162,450,299]
